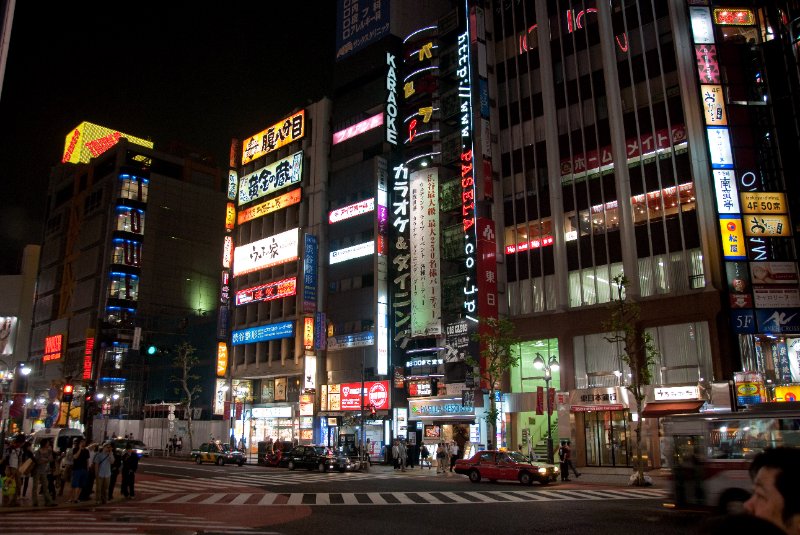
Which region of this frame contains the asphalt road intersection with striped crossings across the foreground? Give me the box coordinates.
[0,458,707,535]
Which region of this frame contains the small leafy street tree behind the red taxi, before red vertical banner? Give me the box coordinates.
[467,318,520,448]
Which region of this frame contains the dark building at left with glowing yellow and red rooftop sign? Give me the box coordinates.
[29,123,225,436]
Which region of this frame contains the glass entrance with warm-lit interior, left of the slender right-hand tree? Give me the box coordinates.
[583,410,631,466]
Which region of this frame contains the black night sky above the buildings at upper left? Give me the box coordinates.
[0,0,336,274]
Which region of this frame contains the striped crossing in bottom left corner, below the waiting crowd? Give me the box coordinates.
[0,504,278,535]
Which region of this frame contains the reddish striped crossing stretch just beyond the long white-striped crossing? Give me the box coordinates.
[136,470,395,493]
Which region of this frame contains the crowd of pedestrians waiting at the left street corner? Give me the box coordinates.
[0,435,139,507]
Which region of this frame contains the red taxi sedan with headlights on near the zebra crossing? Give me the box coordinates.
[454,450,559,485]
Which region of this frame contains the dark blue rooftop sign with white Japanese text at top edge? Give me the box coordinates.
[336,0,389,61]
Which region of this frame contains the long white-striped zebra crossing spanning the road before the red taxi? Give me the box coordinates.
[137,487,667,506]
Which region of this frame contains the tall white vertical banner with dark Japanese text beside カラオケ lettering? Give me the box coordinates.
[410,169,442,336]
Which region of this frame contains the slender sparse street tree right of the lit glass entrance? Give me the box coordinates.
[603,274,658,486]
